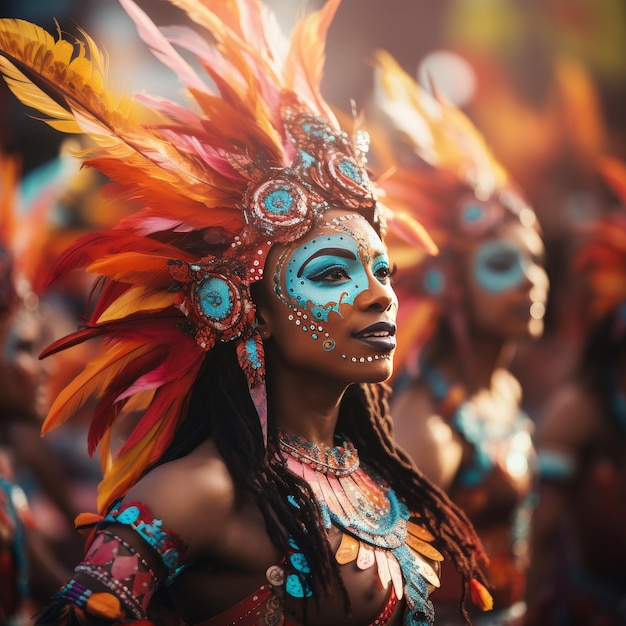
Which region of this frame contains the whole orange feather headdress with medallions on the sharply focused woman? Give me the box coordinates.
[0,0,428,508]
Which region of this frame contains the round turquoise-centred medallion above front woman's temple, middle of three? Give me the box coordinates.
[245,178,313,242]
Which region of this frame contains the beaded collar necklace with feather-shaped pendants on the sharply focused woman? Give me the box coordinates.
[279,433,443,626]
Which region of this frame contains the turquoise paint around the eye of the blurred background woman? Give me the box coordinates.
[473,240,534,293]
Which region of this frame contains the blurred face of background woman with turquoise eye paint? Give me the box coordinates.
[466,223,548,338]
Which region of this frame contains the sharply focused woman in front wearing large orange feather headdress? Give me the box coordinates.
[0,0,488,626]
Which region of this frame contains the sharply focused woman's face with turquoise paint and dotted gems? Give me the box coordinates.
[257,210,397,384]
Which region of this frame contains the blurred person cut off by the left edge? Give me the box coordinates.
[0,155,67,625]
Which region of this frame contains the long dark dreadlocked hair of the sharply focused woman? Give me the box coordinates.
[148,334,487,623]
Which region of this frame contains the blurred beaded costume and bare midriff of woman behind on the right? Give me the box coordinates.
[420,363,535,624]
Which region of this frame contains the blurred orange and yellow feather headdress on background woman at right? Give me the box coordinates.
[366,51,538,366]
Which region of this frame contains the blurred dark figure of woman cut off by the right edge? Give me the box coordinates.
[527,158,626,626]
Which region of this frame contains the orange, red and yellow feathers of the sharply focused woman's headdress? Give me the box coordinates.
[0,0,358,509]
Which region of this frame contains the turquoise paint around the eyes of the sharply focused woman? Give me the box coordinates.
[284,234,389,321]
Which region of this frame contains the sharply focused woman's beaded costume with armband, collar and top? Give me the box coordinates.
[37,436,443,626]
